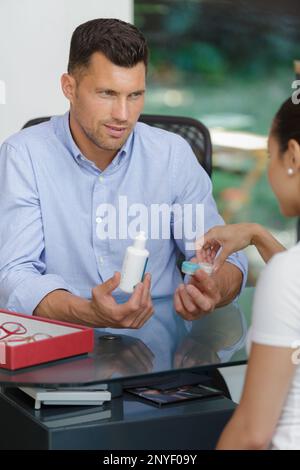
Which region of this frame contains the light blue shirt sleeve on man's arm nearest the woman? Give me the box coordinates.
[172,138,248,287]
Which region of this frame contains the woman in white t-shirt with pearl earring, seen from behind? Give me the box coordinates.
[198,99,300,449]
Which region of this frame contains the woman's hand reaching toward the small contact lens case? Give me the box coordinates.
[196,223,258,272]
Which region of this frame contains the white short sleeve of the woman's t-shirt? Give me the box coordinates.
[250,249,300,347]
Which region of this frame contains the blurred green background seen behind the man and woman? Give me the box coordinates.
[134,0,300,284]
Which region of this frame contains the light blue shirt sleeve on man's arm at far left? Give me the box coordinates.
[0,143,76,314]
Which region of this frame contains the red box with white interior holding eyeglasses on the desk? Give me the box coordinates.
[0,310,94,370]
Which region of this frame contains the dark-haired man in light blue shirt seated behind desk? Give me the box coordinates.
[0,19,246,328]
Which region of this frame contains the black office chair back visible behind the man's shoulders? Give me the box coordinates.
[23,114,212,177]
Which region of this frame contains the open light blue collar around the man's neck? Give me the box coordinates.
[57,111,134,171]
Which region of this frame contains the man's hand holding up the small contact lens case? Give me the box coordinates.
[174,269,221,320]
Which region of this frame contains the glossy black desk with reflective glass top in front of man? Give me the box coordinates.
[0,290,249,450]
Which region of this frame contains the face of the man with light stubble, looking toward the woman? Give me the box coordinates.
[64,52,146,152]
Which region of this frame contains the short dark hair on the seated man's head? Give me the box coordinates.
[68,18,148,74]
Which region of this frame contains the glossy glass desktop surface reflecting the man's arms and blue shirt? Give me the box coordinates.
[0,297,246,387]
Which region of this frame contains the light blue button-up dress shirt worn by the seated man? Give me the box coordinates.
[0,113,247,314]
